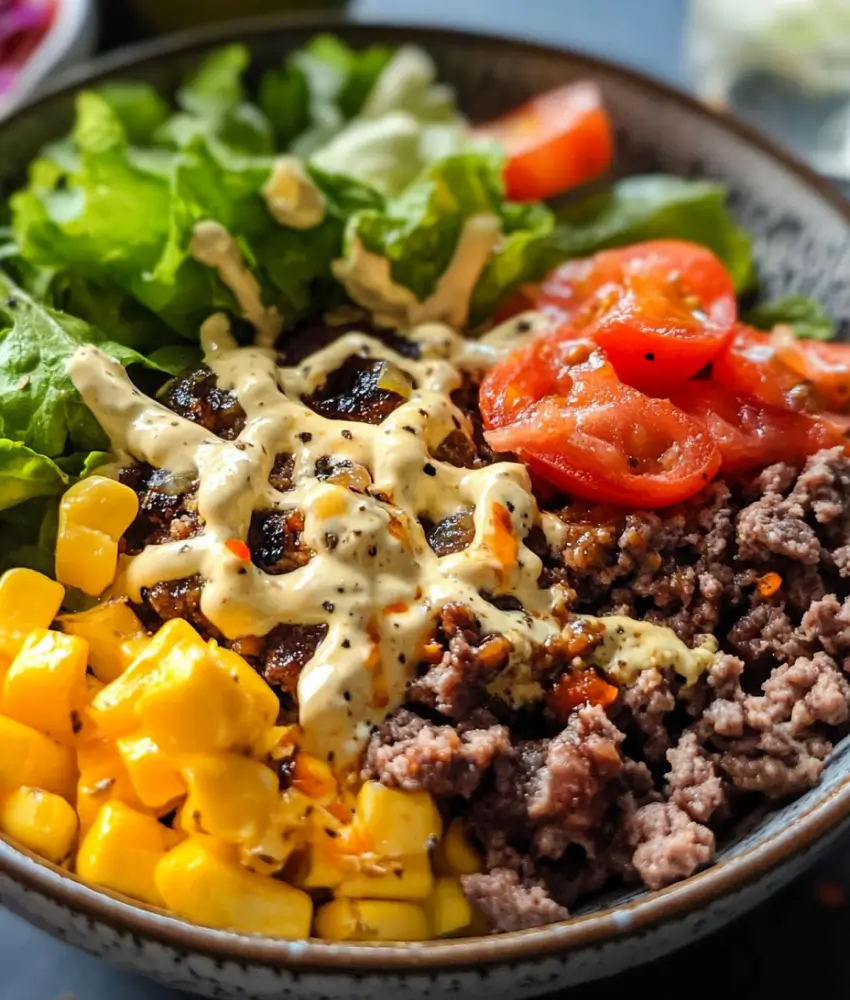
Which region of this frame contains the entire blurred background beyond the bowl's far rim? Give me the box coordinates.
[8,0,850,181]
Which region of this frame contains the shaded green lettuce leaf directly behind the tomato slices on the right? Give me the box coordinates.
[557,174,755,294]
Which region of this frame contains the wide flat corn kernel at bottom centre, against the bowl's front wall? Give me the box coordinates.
[315,899,430,941]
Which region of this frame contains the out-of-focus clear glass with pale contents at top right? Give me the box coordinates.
[685,0,850,181]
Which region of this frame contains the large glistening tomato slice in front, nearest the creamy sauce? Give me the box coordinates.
[479,334,720,507]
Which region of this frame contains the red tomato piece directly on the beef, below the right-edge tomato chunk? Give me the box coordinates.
[670,379,846,472]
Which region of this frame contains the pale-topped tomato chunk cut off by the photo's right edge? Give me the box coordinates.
[714,323,850,414]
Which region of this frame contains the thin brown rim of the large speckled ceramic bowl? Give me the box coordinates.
[0,14,850,975]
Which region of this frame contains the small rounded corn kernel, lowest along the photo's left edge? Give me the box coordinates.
[0,787,78,865]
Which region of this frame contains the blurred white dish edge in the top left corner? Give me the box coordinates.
[0,0,97,119]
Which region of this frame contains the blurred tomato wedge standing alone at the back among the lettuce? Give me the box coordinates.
[472,82,614,201]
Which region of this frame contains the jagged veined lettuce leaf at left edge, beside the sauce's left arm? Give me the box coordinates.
[0,271,166,458]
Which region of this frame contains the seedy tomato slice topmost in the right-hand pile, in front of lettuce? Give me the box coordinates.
[537,240,737,395]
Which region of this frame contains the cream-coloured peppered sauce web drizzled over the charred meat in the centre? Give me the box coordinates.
[70,314,716,766]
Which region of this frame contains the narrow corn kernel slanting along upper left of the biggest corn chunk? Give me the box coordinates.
[91,618,206,736]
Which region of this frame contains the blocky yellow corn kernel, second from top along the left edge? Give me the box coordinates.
[3,629,88,743]
